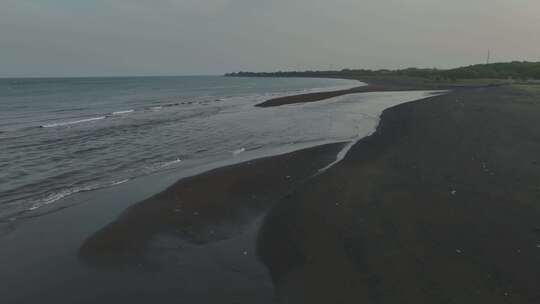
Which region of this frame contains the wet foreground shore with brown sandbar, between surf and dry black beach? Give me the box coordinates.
[0,143,344,304]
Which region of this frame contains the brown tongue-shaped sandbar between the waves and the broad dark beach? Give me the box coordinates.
[79,143,343,268]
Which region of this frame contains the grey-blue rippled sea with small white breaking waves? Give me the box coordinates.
[0,76,358,221]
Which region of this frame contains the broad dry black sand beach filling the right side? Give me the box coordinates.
[259,87,540,304]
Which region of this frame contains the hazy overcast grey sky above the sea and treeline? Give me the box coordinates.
[0,0,540,77]
